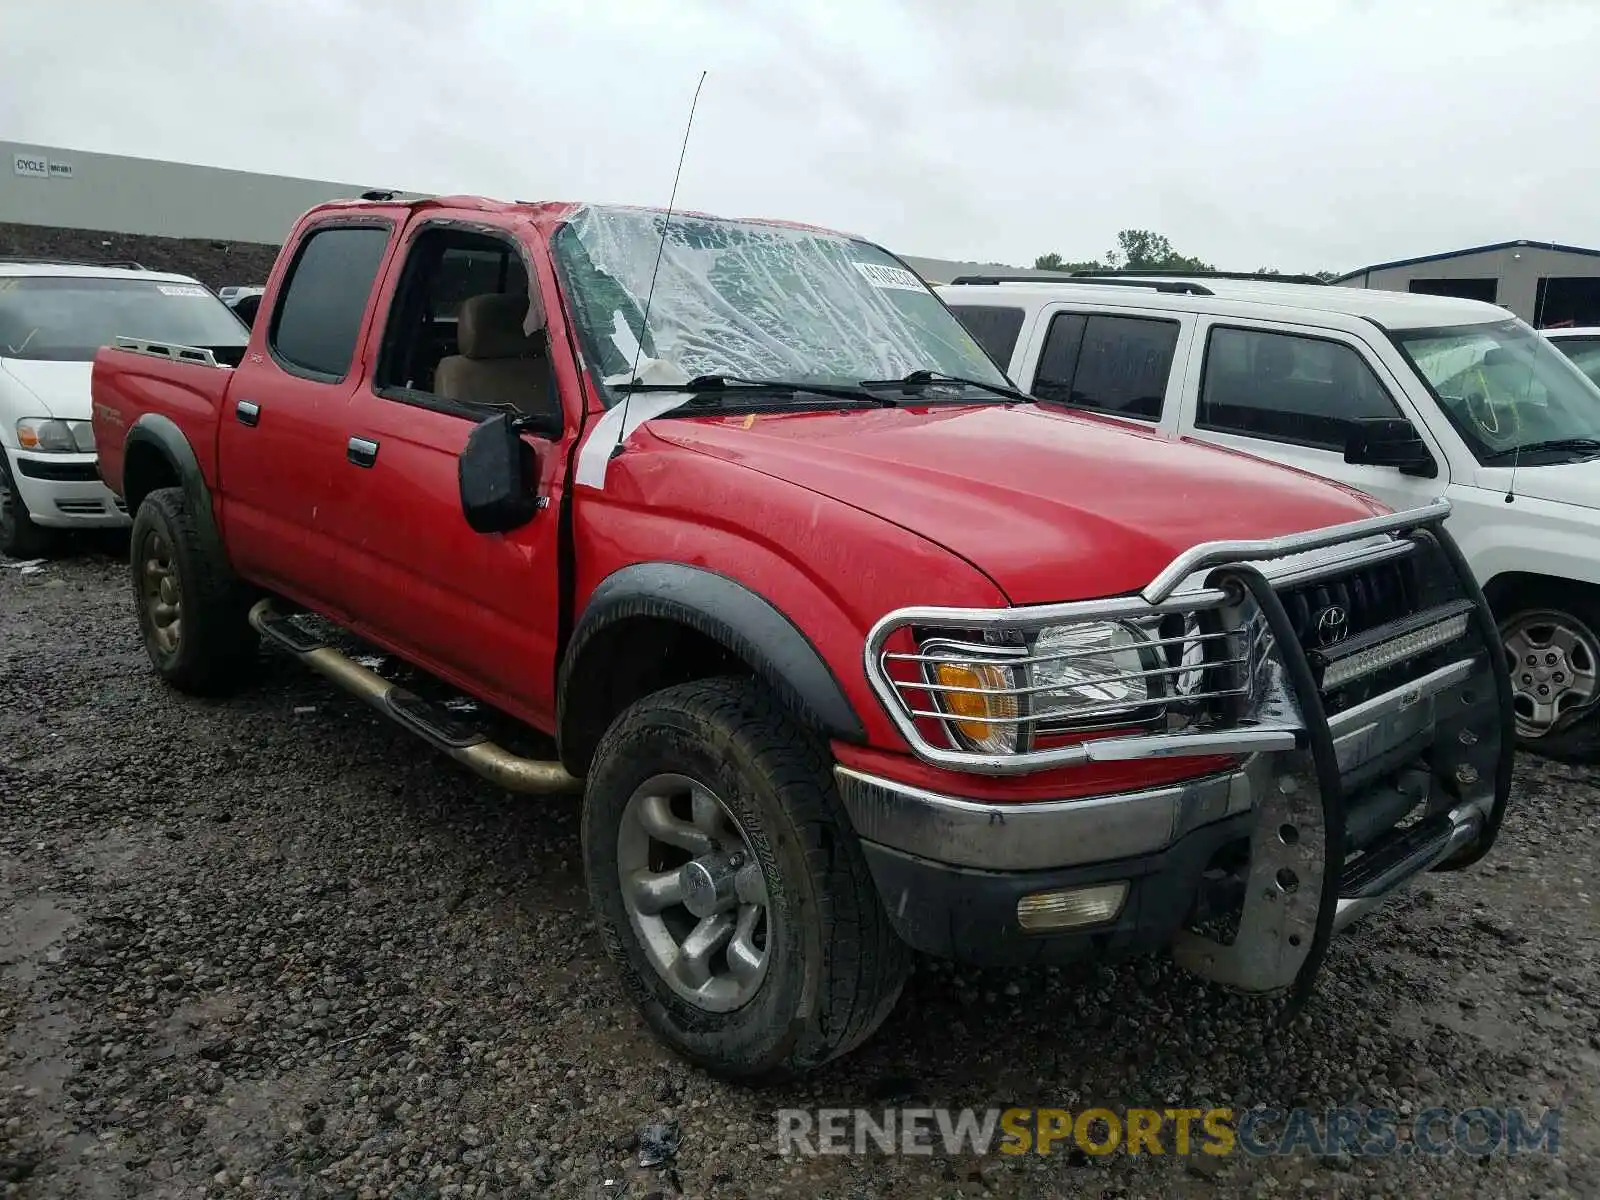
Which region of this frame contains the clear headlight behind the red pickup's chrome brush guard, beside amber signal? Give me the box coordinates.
[1032,621,1163,725]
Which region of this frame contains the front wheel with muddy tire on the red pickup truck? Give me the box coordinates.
[582,678,910,1078]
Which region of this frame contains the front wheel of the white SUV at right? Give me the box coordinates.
[1494,581,1600,763]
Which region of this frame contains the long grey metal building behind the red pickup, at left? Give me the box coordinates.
[0,141,422,288]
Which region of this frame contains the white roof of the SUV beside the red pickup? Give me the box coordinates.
[941,274,1512,330]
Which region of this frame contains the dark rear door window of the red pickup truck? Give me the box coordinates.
[267,226,389,379]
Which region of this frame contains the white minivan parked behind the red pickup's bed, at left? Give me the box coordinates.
[0,259,250,558]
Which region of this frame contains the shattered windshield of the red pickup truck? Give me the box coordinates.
[552,208,1006,403]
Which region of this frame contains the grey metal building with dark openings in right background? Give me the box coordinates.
[1334,242,1600,328]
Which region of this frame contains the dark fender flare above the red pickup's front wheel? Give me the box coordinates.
[557,562,867,761]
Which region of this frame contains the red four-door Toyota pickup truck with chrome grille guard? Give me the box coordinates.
[93,197,1512,1075]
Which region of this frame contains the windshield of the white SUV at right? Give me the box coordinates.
[1394,320,1600,466]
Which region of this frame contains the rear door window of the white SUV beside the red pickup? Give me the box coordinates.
[1034,312,1179,421]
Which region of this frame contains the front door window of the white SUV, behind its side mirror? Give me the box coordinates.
[1195,326,1400,450]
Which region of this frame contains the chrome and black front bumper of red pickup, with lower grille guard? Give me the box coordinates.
[835,508,1514,994]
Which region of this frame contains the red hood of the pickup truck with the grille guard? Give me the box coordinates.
[650,405,1387,603]
